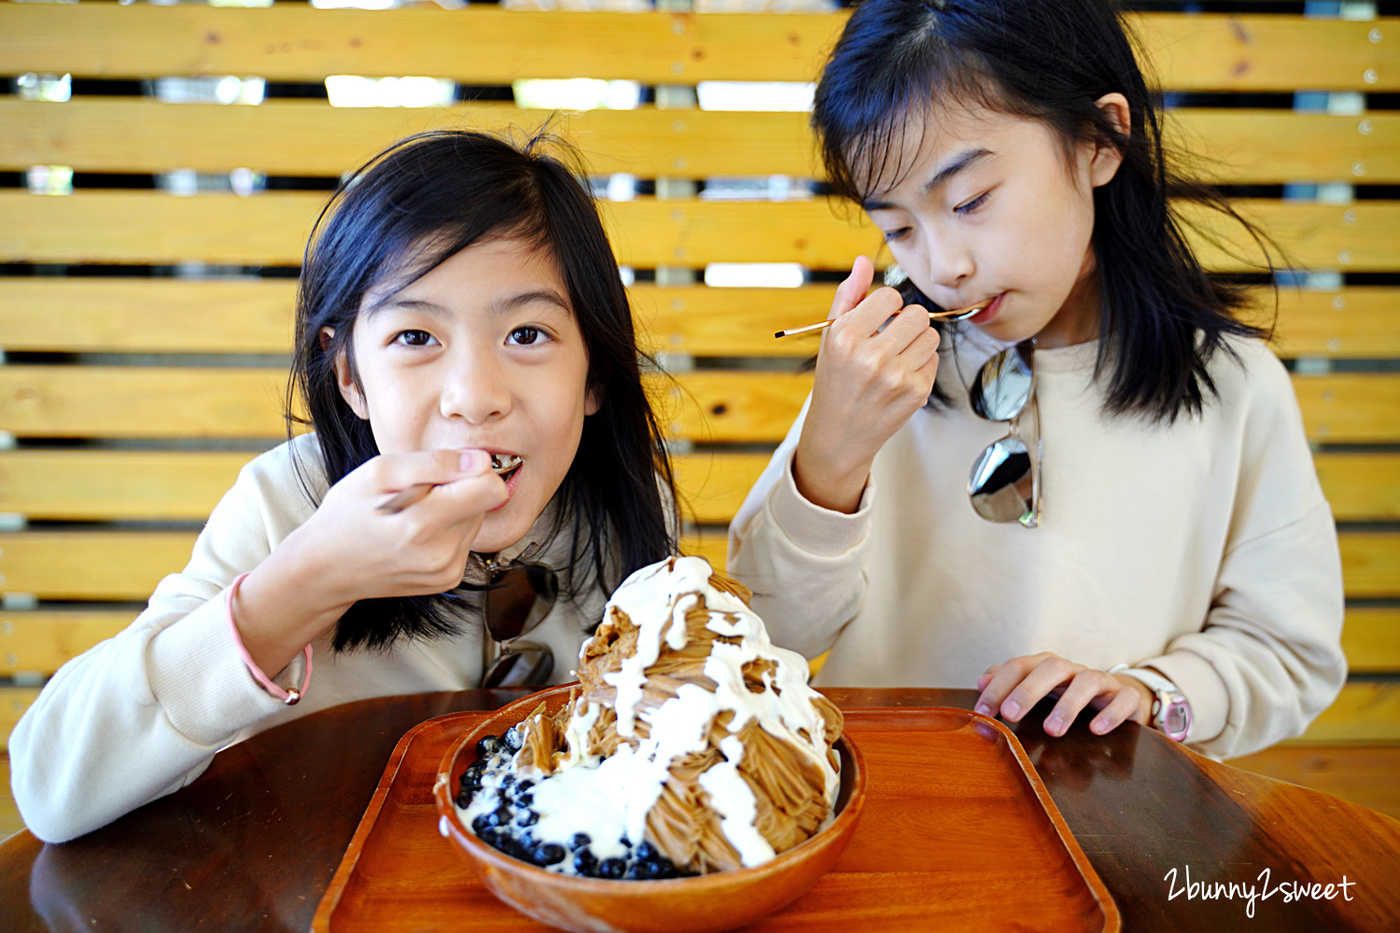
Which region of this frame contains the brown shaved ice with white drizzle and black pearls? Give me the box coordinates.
[456,558,841,878]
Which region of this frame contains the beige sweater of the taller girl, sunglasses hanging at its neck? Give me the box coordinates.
[729,332,1345,756]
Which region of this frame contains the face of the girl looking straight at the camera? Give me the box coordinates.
[336,240,598,553]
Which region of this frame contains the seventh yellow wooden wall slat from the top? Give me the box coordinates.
[0,528,1400,600]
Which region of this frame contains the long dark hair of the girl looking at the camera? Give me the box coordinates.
[288,129,675,649]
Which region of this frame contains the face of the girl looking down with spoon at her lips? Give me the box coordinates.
[864,94,1127,347]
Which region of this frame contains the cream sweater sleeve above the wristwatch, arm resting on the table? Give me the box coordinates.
[1140,352,1347,758]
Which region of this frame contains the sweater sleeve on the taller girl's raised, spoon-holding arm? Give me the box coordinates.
[727,399,875,658]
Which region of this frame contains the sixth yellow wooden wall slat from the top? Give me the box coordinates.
[0,450,1400,525]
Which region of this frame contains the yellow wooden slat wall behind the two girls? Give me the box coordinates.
[0,3,1400,767]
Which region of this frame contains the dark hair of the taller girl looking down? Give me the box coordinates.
[812,0,1271,420]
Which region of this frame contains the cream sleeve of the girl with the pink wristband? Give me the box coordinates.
[10,448,309,842]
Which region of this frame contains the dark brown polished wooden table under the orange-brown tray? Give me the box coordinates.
[0,689,1400,933]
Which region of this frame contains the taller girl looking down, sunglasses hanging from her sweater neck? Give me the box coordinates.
[729,0,1345,755]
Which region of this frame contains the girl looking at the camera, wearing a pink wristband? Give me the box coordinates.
[10,130,675,841]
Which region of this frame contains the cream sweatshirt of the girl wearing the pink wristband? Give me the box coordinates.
[10,434,606,842]
